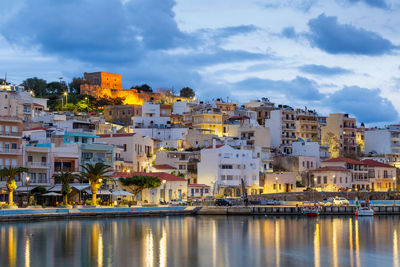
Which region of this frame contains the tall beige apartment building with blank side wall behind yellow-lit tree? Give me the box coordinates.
[321,113,357,158]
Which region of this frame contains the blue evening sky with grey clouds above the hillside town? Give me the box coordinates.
[0,0,400,126]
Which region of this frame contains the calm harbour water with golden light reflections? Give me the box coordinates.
[0,216,400,267]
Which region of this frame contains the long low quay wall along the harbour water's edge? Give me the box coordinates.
[0,205,400,222]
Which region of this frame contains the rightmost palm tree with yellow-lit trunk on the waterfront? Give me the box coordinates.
[80,162,112,205]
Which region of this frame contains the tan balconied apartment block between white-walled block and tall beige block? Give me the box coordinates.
[296,109,320,142]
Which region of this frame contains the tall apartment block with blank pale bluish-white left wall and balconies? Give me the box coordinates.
[265,105,297,154]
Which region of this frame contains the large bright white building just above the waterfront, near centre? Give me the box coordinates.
[197,142,260,195]
